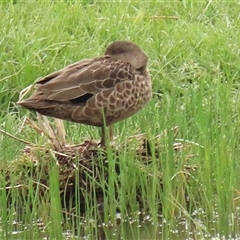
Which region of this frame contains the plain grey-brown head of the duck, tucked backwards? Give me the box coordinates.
[105,41,148,69]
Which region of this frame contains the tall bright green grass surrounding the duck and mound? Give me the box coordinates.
[0,1,240,239]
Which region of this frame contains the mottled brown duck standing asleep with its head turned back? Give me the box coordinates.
[17,41,152,146]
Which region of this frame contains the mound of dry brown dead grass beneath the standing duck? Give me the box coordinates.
[0,115,199,216]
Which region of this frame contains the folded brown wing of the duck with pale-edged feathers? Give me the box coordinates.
[32,56,134,101]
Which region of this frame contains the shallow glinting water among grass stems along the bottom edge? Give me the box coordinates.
[0,208,240,240]
